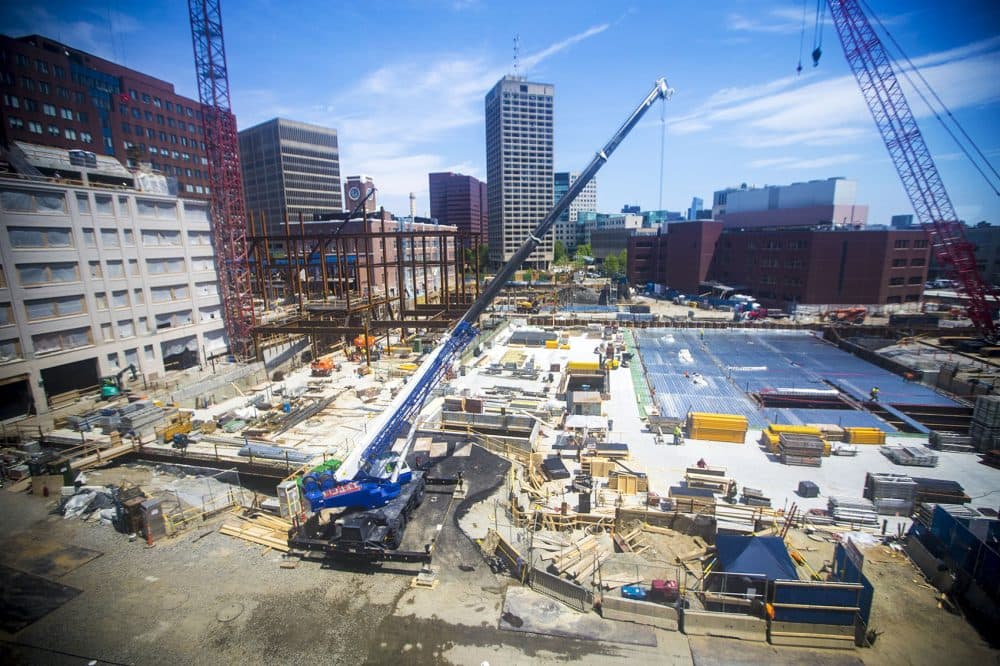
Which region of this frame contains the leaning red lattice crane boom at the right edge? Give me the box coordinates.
[814,0,997,340]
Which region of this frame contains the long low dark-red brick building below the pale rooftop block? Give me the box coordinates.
[628,221,930,307]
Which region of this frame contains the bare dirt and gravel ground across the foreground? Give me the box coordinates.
[0,460,1000,665]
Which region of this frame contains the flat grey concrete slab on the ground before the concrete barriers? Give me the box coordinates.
[500,587,656,646]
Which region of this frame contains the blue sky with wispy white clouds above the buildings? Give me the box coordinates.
[0,0,1000,224]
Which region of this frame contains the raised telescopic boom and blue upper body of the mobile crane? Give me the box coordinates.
[306,78,673,510]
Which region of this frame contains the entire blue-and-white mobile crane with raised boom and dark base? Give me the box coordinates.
[289,79,673,561]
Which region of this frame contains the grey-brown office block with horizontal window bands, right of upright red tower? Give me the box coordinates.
[239,118,343,230]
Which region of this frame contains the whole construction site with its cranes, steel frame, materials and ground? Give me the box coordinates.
[0,1,1000,665]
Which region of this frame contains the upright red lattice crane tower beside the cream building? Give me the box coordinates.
[188,0,254,359]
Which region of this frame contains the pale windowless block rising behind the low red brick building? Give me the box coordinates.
[712,178,868,229]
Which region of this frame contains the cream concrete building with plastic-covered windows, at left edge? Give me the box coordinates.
[0,169,227,418]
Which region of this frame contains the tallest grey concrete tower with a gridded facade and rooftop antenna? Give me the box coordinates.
[485,76,554,269]
